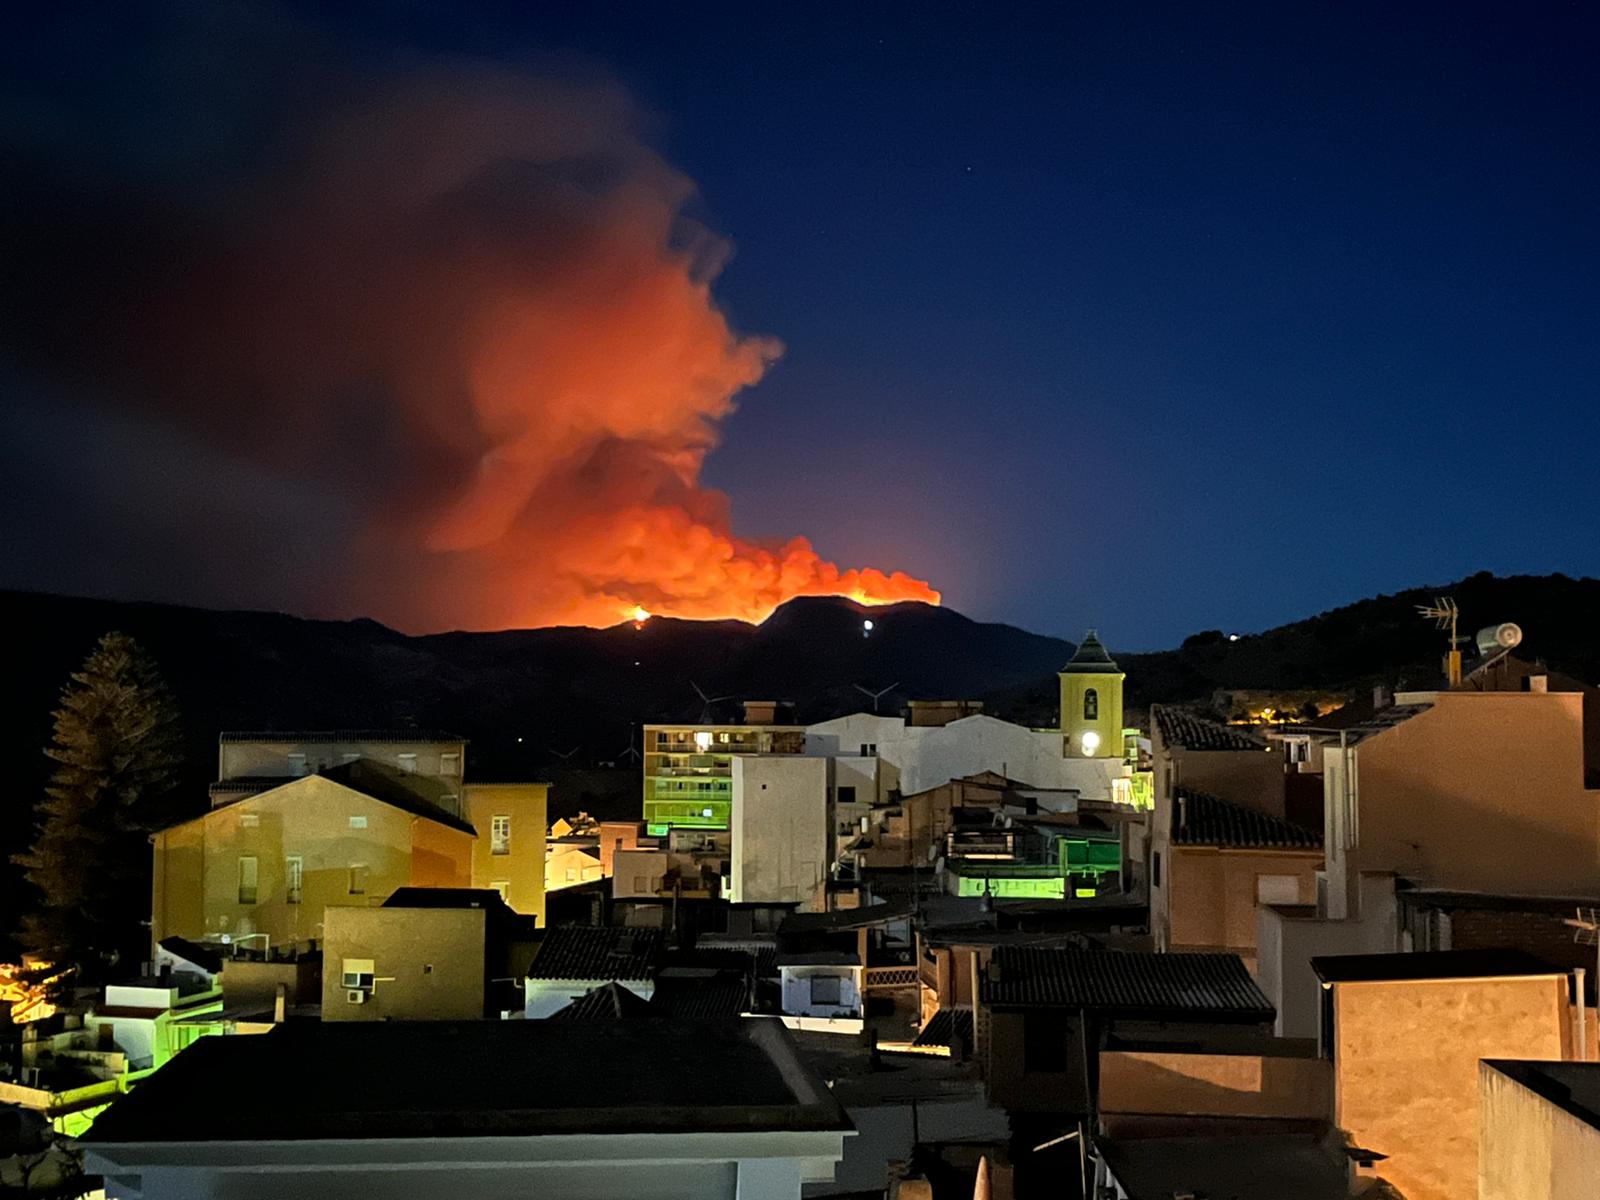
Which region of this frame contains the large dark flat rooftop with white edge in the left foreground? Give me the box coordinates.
[85,1019,851,1144]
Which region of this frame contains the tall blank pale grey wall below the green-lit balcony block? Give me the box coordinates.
[728,755,834,912]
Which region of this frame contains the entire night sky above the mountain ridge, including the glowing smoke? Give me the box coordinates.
[0,2,1600,650]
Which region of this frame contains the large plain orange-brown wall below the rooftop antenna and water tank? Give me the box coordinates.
[1323,693,1600,917]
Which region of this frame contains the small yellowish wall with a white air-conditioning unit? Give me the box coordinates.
[322,909,485,1021]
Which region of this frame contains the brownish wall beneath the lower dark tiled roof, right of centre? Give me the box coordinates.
[1160,846,1322,965]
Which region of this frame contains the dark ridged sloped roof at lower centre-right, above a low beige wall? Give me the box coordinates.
[981,946,1275,1021]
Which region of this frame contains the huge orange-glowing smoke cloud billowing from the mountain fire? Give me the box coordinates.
[0,10,938,629]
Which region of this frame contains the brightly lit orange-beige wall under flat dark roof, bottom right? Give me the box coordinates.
[1333,976,1571,1200]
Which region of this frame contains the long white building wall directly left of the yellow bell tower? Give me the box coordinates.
[805,712,1126,800]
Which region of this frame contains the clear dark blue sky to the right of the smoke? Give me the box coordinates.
[12,2,1600,648]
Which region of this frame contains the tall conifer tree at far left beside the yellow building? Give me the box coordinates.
[14,632,182,979]
